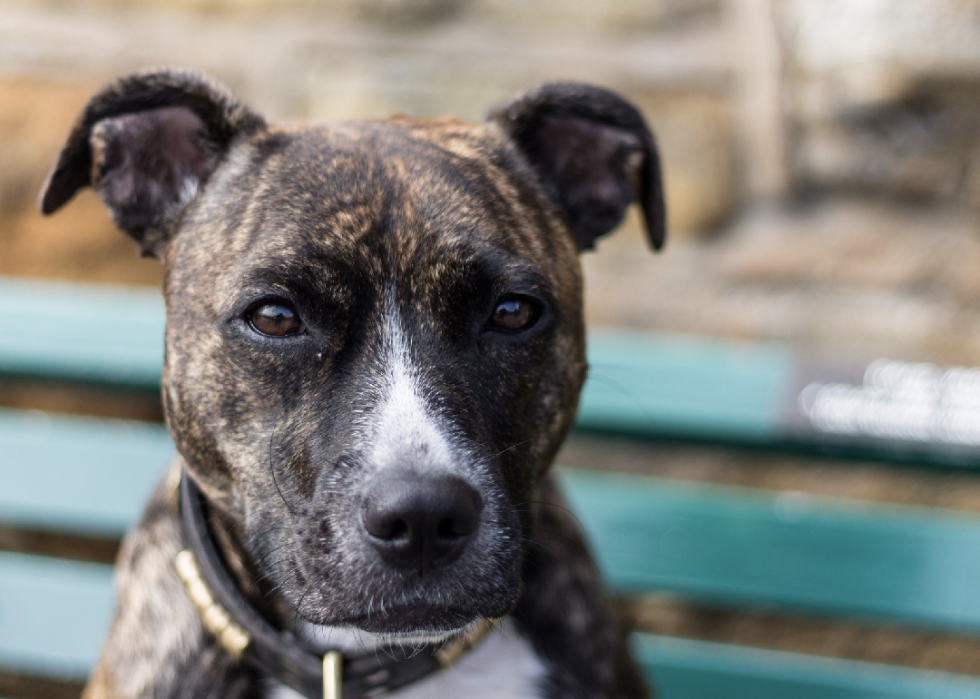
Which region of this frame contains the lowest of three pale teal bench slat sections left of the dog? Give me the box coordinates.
[0,552,113,680]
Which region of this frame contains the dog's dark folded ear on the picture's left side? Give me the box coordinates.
[40,70,265,255]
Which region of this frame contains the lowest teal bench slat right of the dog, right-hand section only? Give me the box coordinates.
[634,634,980,699]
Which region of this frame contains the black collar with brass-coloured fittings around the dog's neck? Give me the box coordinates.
[175,470,495,699]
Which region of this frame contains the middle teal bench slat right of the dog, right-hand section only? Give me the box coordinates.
[562,471,980,633]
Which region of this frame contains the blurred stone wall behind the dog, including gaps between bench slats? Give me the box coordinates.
[9,0,980,696]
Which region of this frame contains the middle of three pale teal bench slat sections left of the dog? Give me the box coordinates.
[0,410,175,537]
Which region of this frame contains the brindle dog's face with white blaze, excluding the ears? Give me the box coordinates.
[164,117,585,631]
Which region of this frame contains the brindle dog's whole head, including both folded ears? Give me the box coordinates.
[42,72,663,635]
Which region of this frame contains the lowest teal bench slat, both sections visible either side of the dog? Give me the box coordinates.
[7,553,980,699]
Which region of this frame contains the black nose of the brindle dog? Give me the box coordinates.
[363,476,482,575]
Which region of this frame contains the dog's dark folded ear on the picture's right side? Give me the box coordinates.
[488,83,665,250]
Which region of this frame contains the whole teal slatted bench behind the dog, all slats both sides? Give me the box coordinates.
[0,280,980,699]
